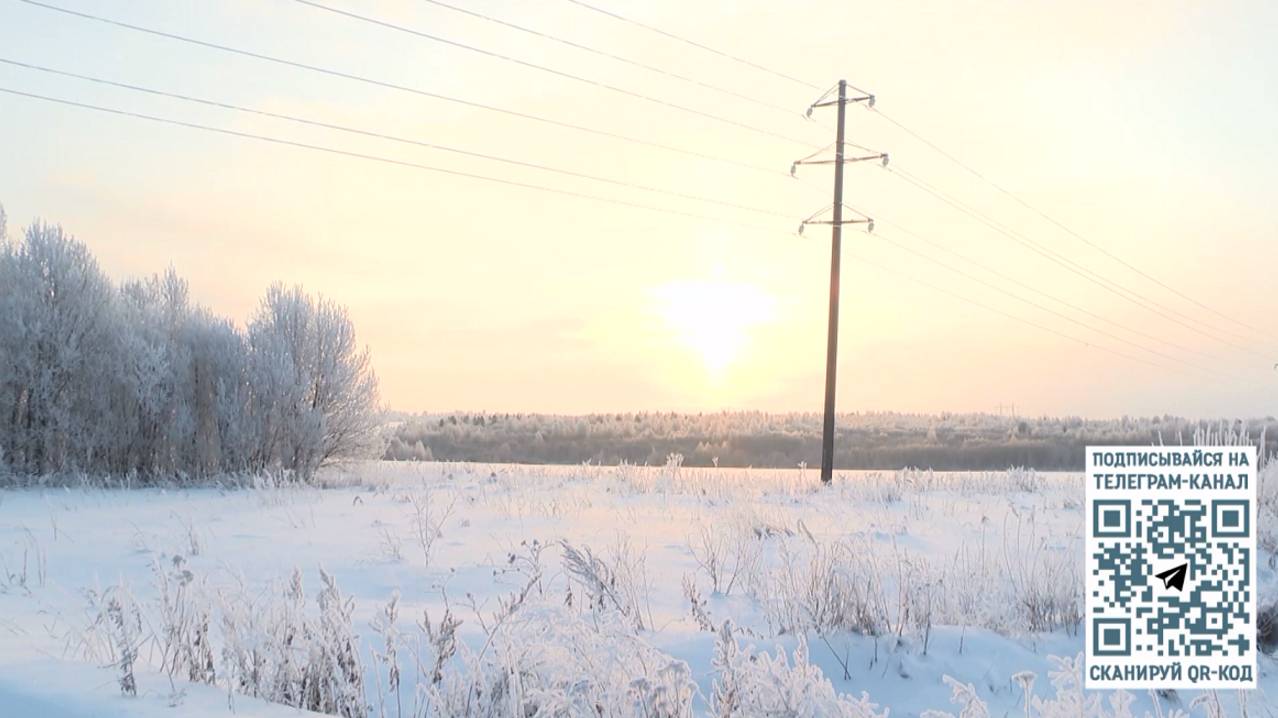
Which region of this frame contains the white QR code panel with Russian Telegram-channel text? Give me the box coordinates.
[1086,448,1256,687]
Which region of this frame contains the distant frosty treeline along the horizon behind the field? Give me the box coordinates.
[386,411,1278,470]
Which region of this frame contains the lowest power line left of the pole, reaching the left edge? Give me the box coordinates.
[0,87,777,234]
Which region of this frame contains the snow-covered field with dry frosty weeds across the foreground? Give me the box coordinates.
[0,461,1278,717]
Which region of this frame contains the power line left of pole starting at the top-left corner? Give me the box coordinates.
[18,0,789,179]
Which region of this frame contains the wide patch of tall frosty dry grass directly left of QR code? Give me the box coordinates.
[749,519,1082,643]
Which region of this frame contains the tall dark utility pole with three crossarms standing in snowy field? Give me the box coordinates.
[790,79,888,484]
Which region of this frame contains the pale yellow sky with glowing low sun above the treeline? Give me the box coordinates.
[0,0,1278,416]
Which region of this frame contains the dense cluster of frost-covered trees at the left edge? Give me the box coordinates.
[0,212,377,479]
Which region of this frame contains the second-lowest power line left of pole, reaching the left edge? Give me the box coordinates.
[0,57,790,217]
